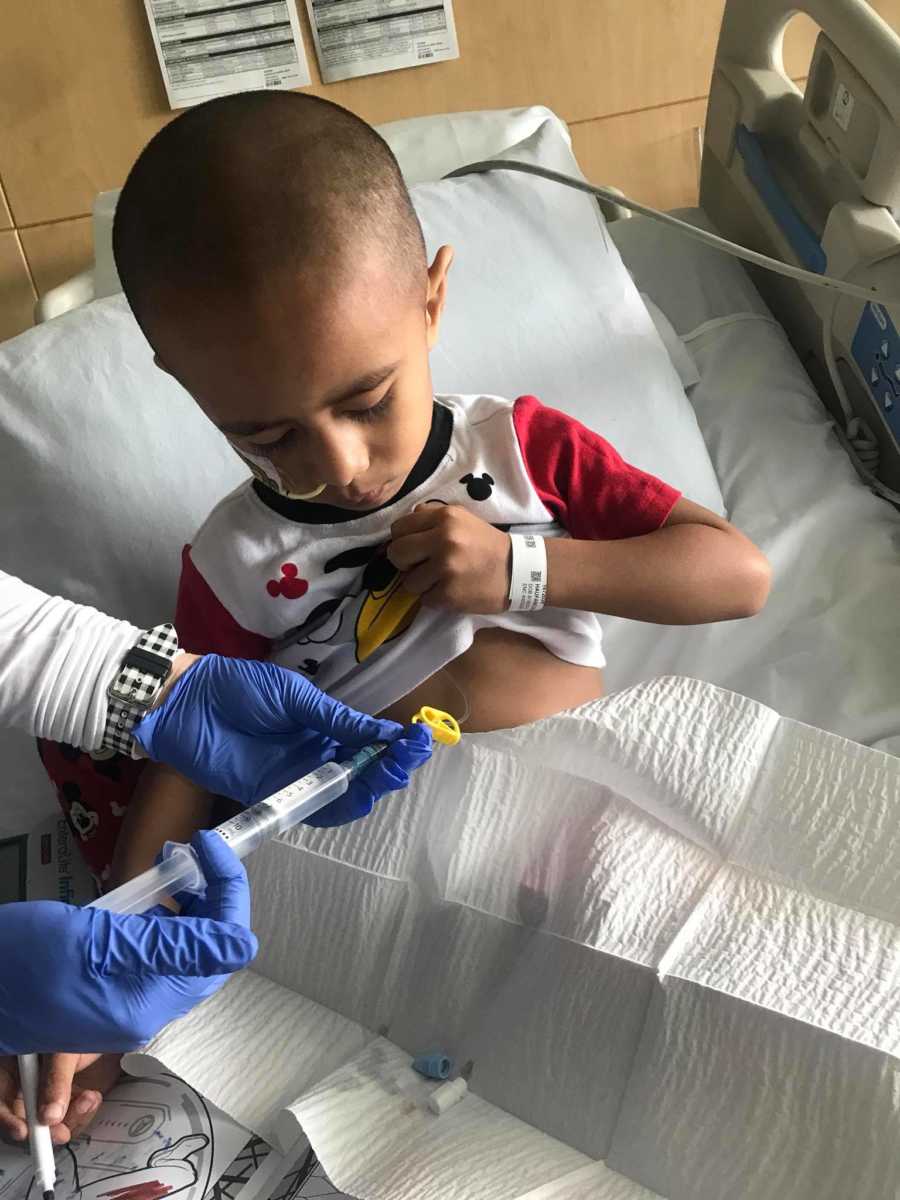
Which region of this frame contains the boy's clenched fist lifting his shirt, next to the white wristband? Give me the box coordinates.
[388,504,510,613]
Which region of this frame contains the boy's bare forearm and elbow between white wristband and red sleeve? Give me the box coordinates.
[546,499,769,625]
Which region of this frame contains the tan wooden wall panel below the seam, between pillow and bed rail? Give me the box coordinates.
[571,100,707,209]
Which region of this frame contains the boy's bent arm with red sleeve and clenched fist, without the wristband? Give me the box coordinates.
[388,396,769,625]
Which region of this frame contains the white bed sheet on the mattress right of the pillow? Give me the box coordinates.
[606,210,900,752]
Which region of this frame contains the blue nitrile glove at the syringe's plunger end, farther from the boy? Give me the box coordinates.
[0,830,257,1054]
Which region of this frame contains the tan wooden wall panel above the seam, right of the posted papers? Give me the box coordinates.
[307,0,724,133]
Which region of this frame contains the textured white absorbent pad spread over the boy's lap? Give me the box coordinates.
[130,678,900,1200]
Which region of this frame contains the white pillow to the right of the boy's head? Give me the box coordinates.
[412,122,725,512]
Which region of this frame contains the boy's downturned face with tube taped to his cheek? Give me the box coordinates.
[152,246,452,511]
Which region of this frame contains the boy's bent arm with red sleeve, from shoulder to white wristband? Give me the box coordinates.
[514,396,769,625]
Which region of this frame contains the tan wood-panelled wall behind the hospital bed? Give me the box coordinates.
[0,0,900,338]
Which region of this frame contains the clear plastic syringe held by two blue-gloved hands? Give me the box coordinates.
[89,742,388,913]
